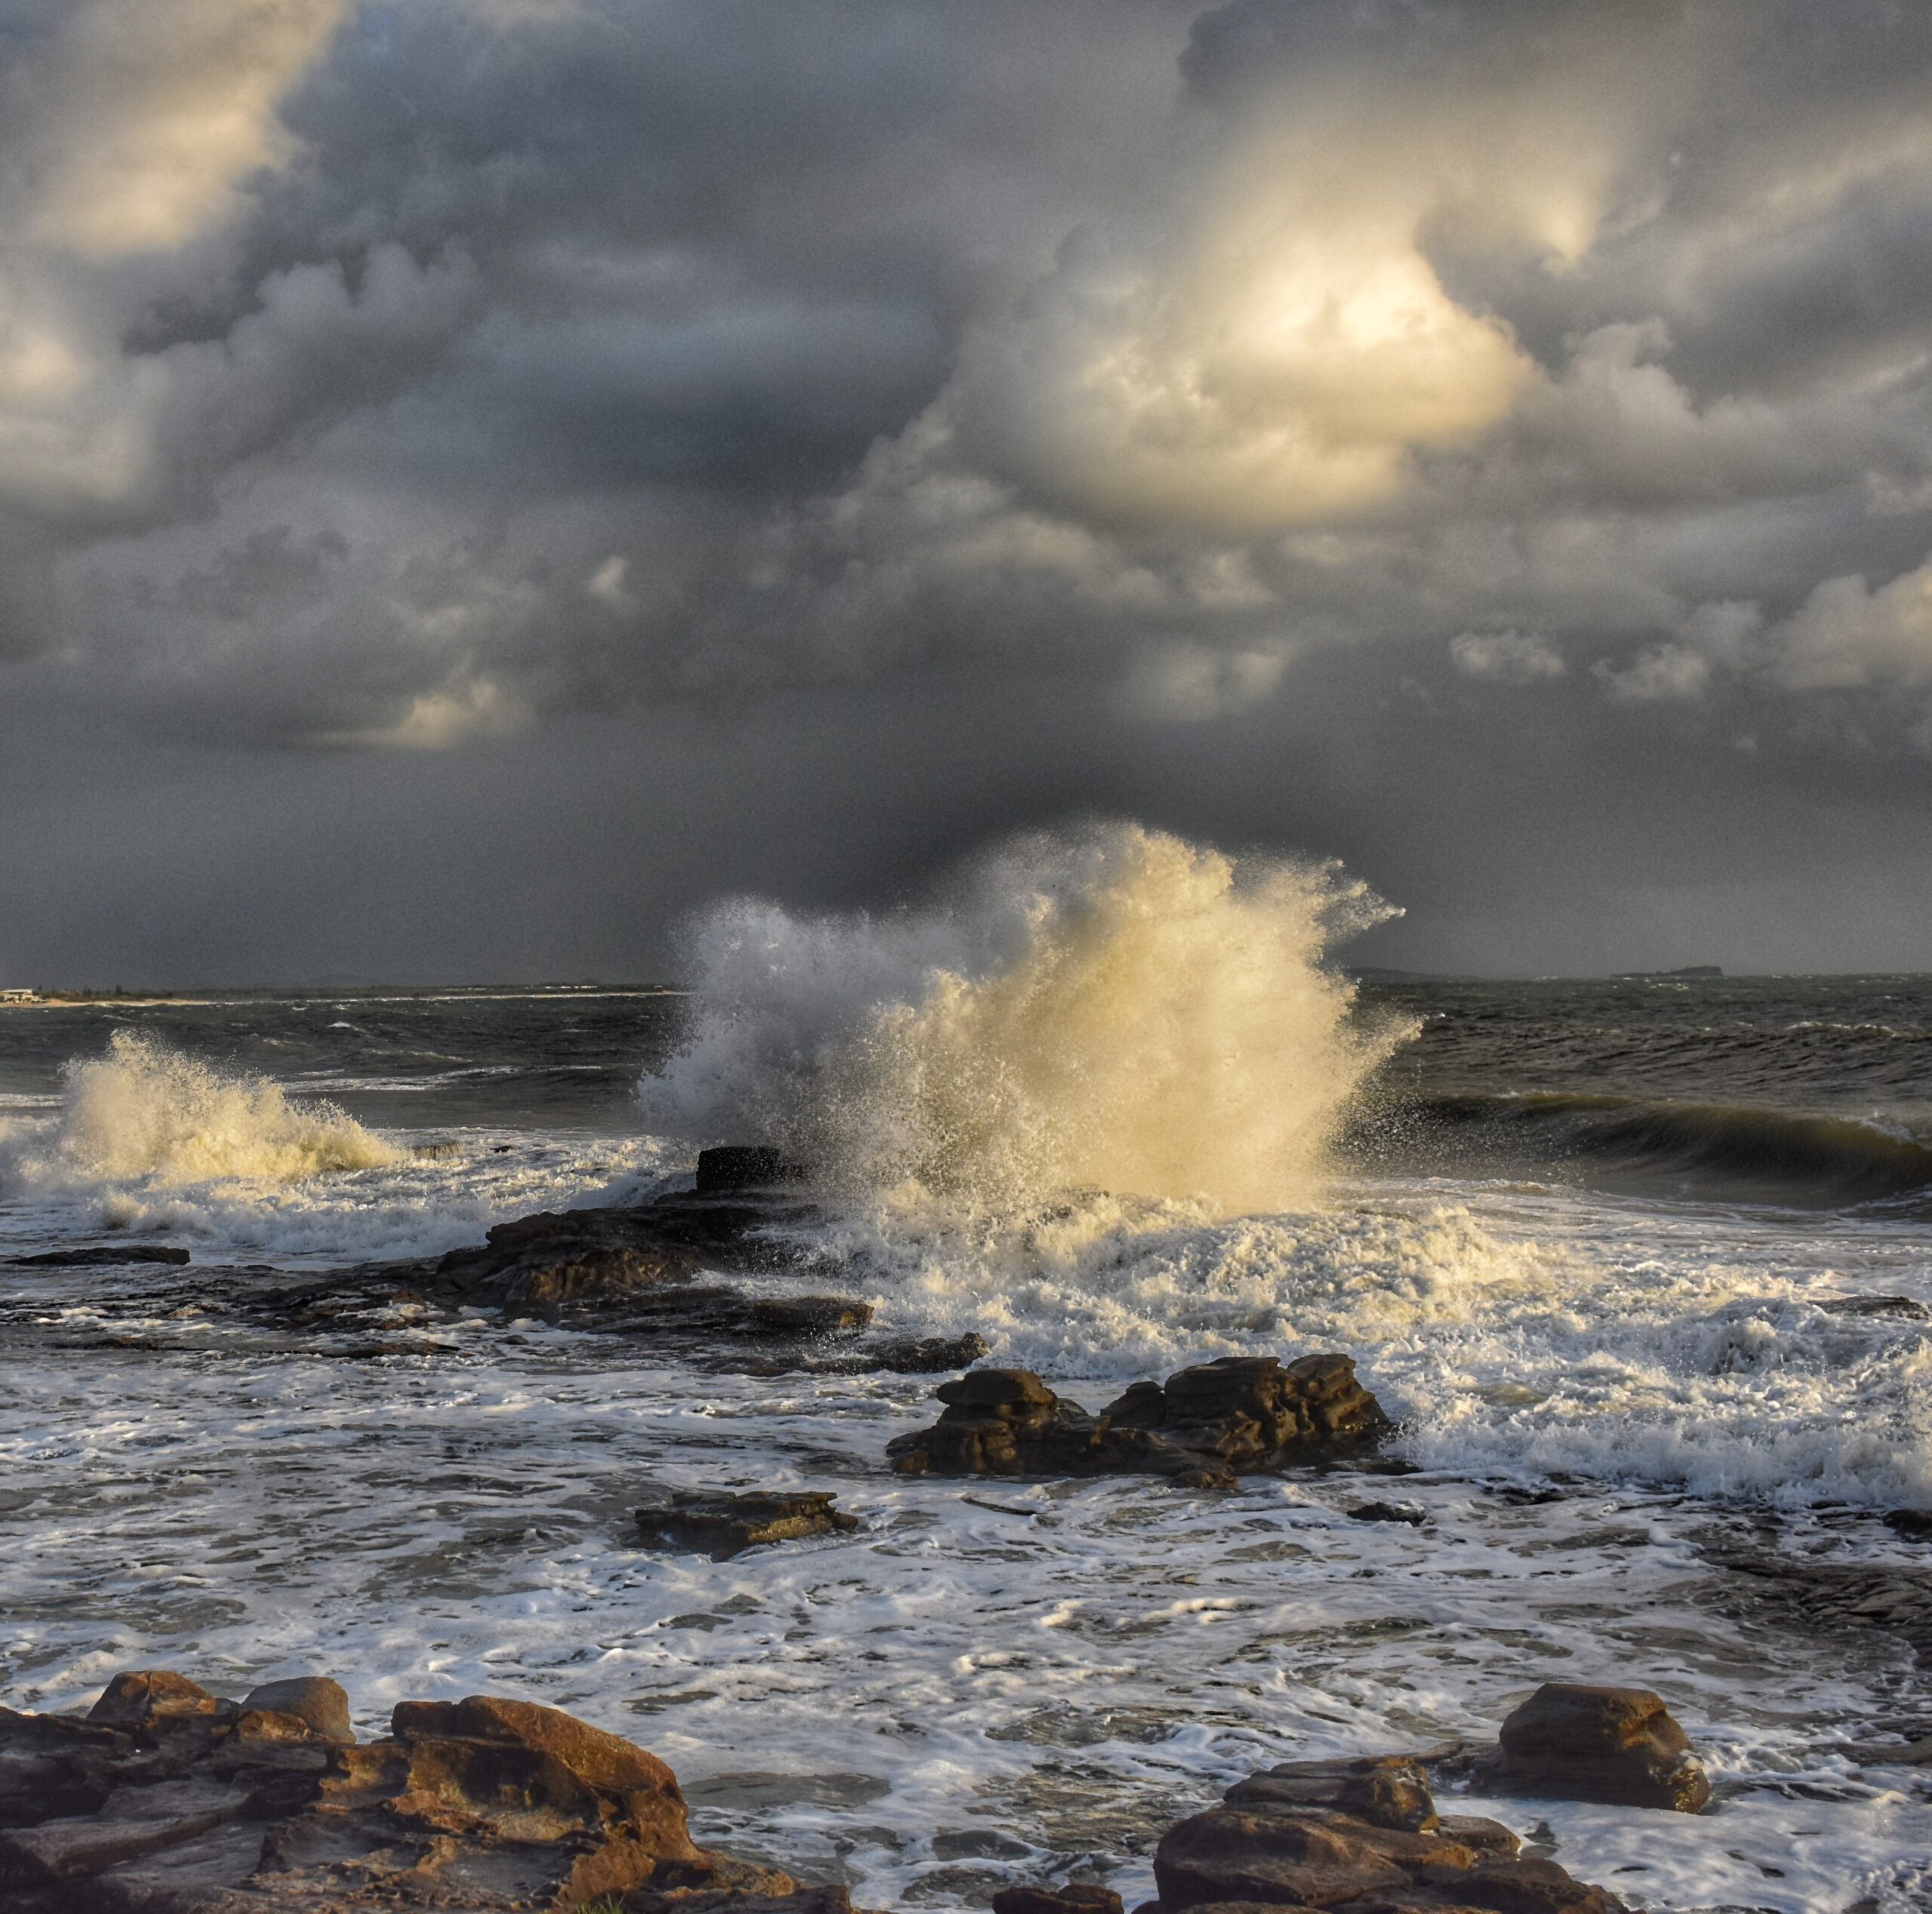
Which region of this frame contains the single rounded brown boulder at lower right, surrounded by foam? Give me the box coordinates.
[1478,1682,1710,1814]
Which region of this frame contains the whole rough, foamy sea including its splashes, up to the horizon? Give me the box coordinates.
[0,826,1932,1914]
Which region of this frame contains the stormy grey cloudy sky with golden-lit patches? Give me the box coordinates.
[0,0,1932,983]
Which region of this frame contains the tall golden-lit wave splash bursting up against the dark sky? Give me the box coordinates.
[638,825,1407,1213]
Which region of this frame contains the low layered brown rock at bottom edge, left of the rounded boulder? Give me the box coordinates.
[1142,1756,1623,1914]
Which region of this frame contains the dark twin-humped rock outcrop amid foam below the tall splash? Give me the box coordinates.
[887,1354,1389,1485]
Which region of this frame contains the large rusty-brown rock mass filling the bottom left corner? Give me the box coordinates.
[0,1671,819,1914]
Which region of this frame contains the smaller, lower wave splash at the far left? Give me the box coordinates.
[0,1029,398,1189]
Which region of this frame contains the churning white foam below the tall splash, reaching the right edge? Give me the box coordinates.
[780,1184,1932,1506]
